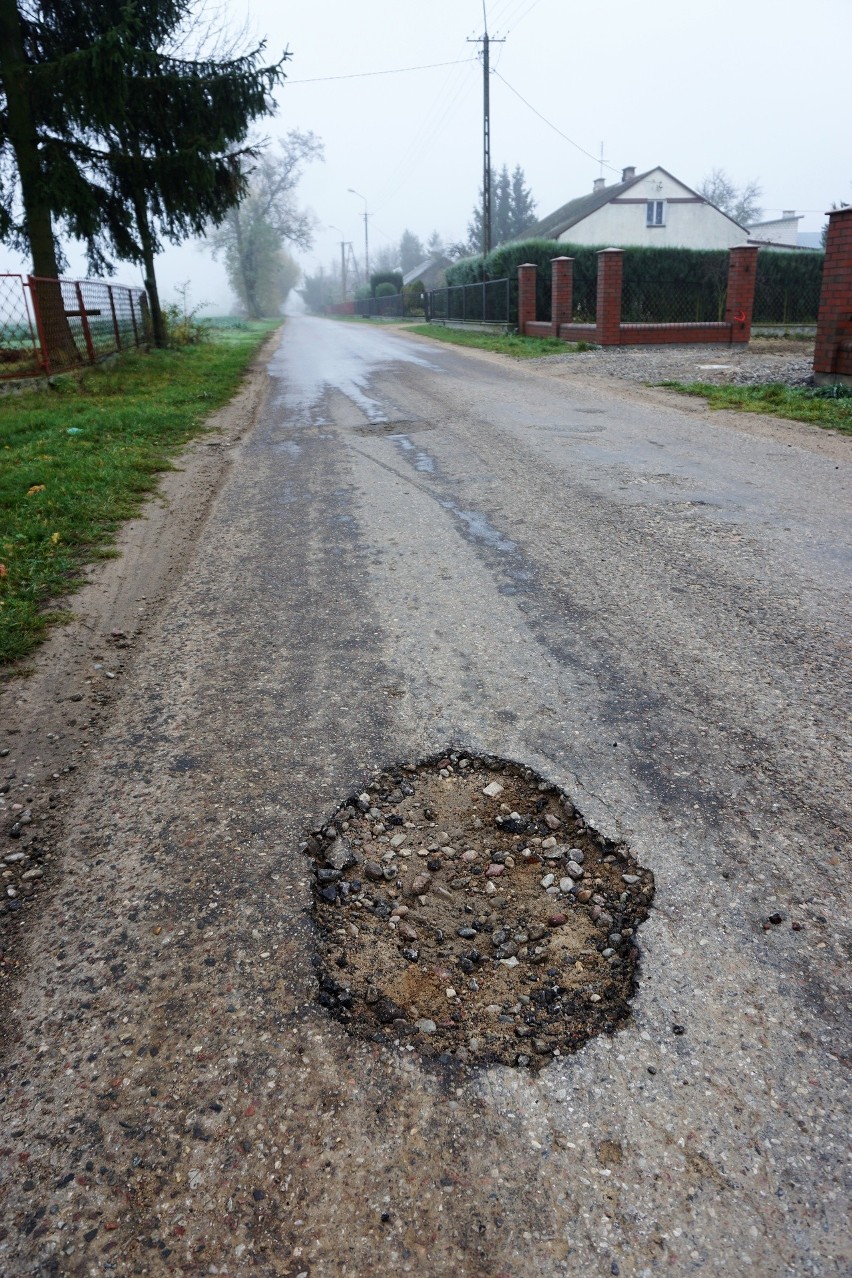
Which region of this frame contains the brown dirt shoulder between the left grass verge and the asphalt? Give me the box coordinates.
[0,332,281,976]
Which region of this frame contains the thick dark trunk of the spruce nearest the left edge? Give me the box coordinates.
[0,0,79,367]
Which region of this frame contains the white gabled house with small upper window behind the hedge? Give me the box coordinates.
[519,167,749,248]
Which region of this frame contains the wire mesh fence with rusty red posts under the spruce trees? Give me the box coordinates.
[0,275,149,380]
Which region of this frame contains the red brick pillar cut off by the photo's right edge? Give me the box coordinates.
[814,208,852,386]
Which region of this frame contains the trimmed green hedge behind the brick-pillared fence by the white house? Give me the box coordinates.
[447,239,824,323]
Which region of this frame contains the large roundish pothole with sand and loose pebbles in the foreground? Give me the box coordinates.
[305,751,654,1068]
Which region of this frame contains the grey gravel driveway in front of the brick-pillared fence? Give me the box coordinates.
[531,346,814,386]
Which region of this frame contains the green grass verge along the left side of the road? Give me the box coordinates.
[0,321,277,666]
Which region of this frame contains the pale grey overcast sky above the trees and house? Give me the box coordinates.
[19,0,852,311]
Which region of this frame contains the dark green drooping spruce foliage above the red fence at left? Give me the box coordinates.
[0,0,289,344]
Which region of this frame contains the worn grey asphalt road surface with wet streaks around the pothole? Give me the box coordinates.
[0,317,849,1278]
